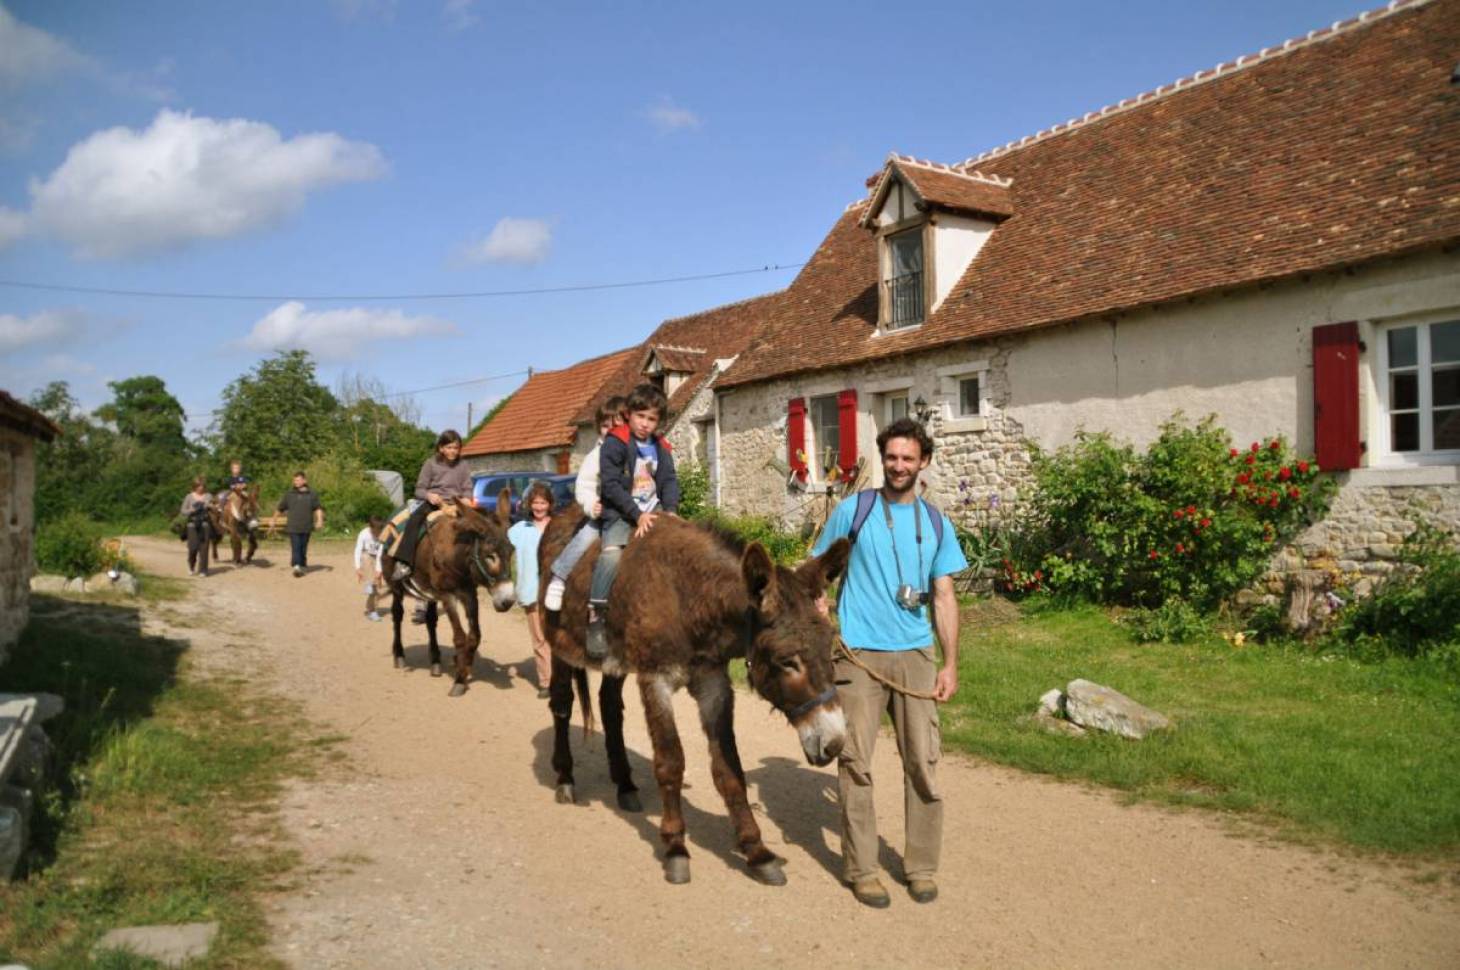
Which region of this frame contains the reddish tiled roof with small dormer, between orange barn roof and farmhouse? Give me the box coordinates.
[574,291,785,424]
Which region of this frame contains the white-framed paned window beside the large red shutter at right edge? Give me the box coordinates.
[1378,320,1460,463]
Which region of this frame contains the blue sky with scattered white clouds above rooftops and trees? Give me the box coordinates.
[0,0,1377,428]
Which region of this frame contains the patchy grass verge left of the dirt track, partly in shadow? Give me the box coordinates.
[0,587,319,970]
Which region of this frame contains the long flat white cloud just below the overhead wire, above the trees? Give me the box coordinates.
[241,299,457,361]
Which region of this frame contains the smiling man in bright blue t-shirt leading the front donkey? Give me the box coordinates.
[812,418,968,909]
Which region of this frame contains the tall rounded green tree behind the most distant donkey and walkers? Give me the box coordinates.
[218,351,339,467]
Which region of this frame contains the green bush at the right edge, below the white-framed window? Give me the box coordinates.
[1329,523,1460,659]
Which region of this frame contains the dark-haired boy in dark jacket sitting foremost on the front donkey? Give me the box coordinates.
[585,384,679,660]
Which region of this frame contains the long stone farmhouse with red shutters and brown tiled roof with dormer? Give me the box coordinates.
[712,0,1460,571]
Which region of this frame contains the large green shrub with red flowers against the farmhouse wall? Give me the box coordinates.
[1012,415,1334,609]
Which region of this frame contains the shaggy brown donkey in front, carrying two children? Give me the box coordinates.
[539,507,851,885]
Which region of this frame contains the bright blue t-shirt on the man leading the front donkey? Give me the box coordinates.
[812,495,968,650]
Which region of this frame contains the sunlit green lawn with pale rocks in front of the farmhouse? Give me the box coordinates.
[943,600,1460,860]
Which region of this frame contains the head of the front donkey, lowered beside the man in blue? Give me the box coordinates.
[740,539,851,764]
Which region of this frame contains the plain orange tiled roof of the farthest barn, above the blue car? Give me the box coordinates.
[461,346,639,457]
